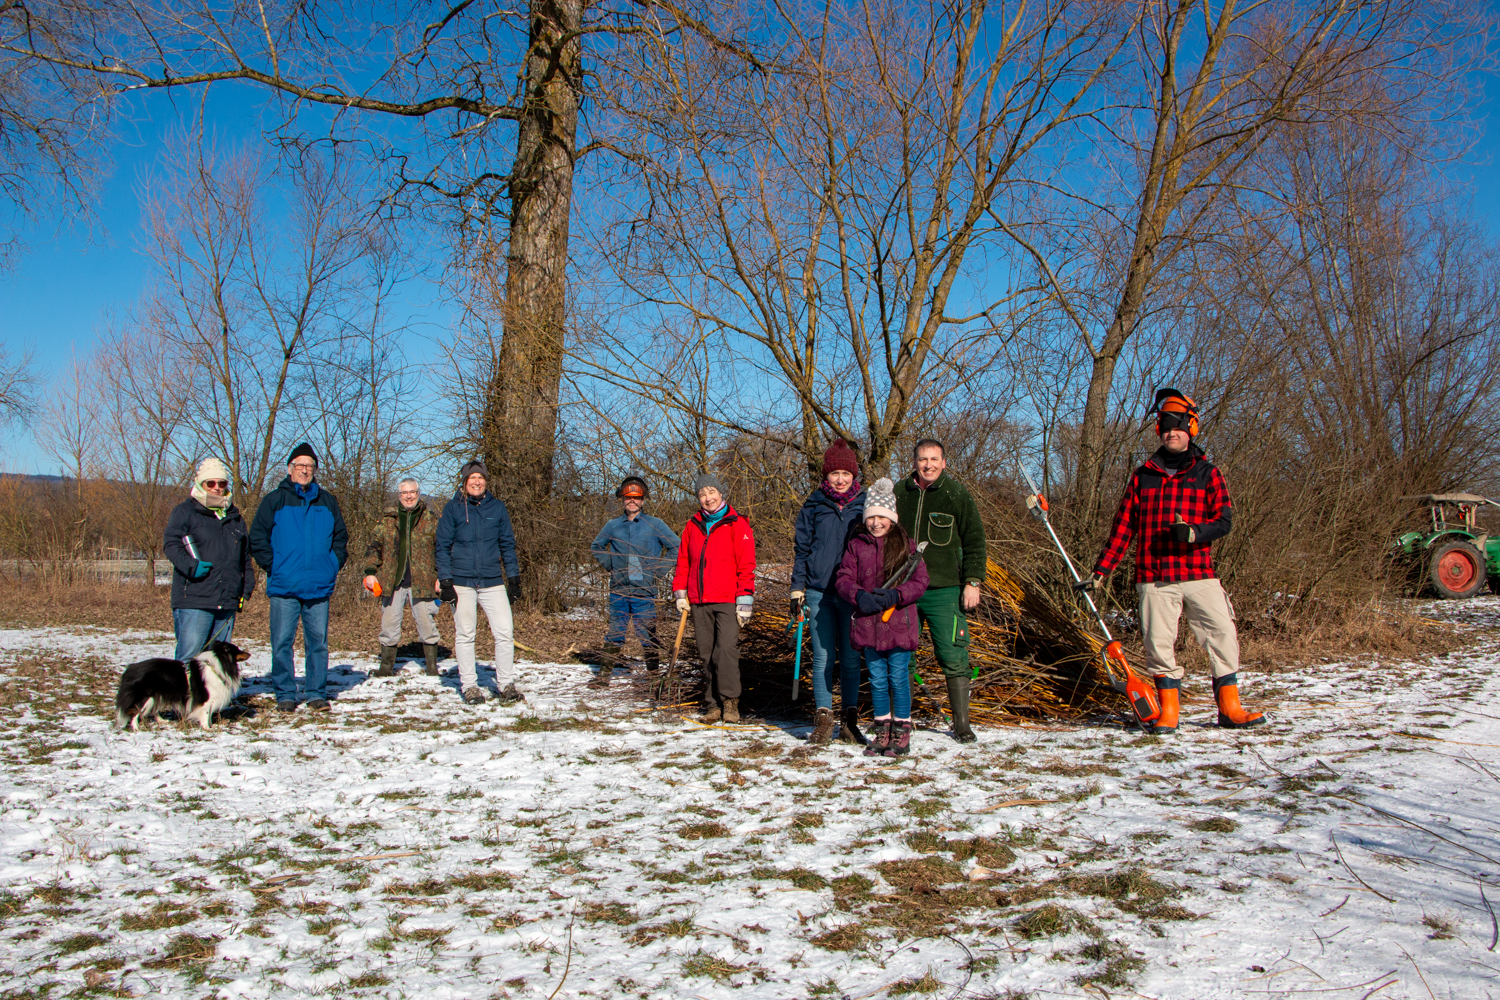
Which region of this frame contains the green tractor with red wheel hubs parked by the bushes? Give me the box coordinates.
[1392,493,1500,598]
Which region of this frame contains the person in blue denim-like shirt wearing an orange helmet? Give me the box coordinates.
[588,475,678,688]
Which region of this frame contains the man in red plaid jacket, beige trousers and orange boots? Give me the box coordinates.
[1080,388,1266,733]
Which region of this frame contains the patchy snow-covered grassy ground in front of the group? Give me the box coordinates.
[0,598,1500,1000]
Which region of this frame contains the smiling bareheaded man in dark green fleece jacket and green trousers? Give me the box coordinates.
[896,438,986,744]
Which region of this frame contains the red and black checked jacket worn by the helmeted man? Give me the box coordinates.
[1094,445,1235,583]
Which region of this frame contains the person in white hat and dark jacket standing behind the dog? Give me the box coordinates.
[162,457,255,660]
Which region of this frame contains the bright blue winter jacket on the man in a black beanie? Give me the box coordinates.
[251,477,350,601]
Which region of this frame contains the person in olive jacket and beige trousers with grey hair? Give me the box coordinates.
[365,478,440,678]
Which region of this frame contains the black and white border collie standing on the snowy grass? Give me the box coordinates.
[114,640,251,732]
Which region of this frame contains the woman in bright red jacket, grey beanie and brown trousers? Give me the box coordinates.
[672,472,755,723]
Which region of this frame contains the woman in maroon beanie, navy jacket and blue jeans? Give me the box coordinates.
[792,441,870,745]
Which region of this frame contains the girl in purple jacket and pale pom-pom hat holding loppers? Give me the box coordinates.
[834,480,927,757]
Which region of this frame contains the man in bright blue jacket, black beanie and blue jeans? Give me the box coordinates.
[251,441,350,712]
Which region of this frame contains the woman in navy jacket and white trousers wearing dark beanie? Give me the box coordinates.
[437,459,521,705]
